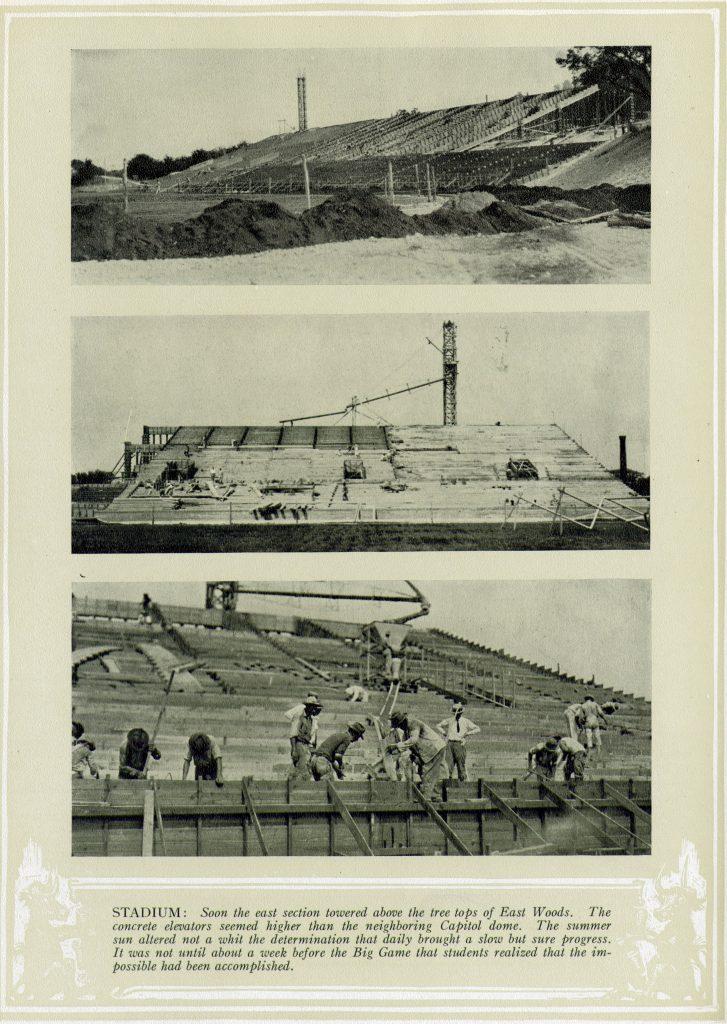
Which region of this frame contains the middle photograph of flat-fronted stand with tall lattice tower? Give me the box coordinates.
[71,310,650,553]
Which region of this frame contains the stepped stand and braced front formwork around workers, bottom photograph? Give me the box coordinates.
[73,598,651,856]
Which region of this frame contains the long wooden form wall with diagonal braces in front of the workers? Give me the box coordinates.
[73,779,651,857]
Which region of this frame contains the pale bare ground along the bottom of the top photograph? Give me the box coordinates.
[73,223,651,285]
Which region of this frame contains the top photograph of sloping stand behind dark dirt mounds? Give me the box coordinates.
[71,46,651,286]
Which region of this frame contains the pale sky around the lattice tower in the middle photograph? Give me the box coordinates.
[72,313,649,472]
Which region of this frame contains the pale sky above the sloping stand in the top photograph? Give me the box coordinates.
[72,47,568,170]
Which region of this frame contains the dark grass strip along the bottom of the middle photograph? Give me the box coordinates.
[72,521,649,554]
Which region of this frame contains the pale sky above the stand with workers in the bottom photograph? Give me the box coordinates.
[74,580,651,698]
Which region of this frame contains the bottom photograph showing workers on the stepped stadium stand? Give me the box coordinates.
[71,580,651,857]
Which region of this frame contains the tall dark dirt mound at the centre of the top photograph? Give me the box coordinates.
[300,188,414,245]
